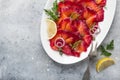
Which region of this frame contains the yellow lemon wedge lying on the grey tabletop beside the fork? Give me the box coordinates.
[96,57,115,72]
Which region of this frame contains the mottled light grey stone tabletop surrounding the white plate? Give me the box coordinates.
[0,0,120,80]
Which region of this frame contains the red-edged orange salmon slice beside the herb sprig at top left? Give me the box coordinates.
[58,1,84,18]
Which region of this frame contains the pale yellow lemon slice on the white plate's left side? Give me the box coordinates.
[46,19,57,39]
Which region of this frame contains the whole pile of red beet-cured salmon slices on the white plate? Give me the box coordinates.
[49,0,106,57]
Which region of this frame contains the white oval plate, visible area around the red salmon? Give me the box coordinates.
[40,0,116,64]
